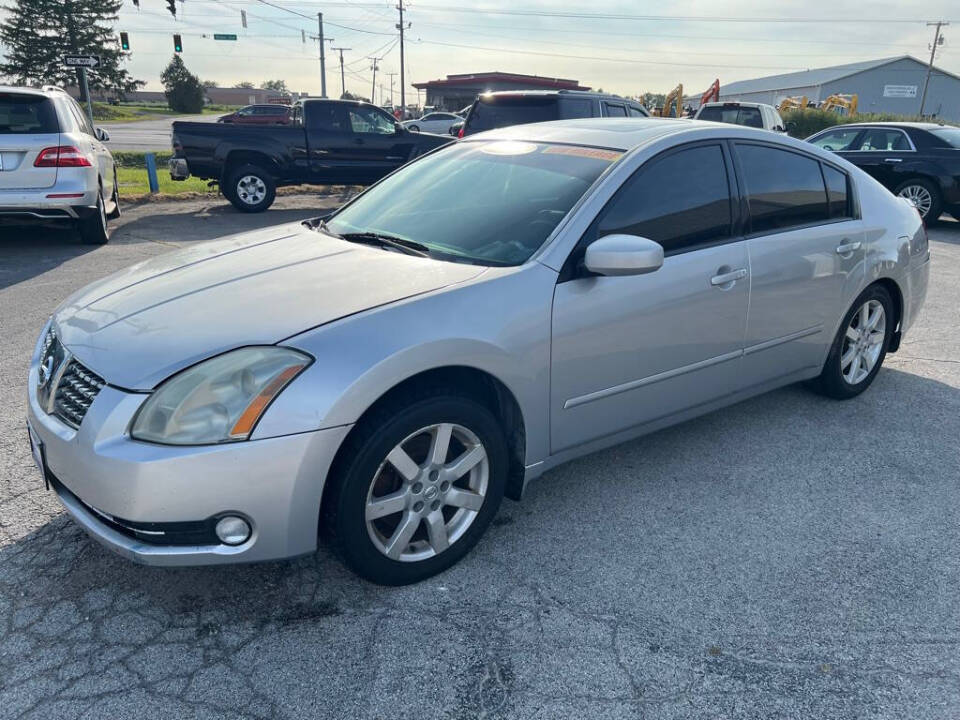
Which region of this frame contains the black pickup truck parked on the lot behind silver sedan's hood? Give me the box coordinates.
[170,99,452,212]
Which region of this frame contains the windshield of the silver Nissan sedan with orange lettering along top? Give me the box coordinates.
[325,141,622,265]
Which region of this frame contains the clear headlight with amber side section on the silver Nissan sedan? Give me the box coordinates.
[130,347,312,445]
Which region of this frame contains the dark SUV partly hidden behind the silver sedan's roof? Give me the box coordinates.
[459,90,650,137]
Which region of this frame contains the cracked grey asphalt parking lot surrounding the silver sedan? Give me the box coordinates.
[0,196,960,720]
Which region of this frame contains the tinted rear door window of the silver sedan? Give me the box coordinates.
[737,144,830,232]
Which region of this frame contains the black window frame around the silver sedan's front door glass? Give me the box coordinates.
[557,138,740,284]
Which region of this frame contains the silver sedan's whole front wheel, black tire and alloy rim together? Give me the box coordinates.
[324,395,508,585]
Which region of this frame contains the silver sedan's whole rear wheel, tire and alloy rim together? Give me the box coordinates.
[814,285,896,400]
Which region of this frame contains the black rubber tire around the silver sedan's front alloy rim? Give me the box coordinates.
[321,389,508,585]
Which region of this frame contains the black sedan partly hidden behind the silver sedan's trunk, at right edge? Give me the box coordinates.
[807,122,960,222]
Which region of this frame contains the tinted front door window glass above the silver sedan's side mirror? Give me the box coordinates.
[597,145,731,252]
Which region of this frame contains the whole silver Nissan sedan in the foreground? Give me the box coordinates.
[28,118,929,584]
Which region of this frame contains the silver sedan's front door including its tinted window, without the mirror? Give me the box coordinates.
[550,143,750,453]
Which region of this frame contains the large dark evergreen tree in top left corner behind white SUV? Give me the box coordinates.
[0,0,144,97]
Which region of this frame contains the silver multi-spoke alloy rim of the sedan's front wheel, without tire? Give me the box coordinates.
[365,423,490,562]
